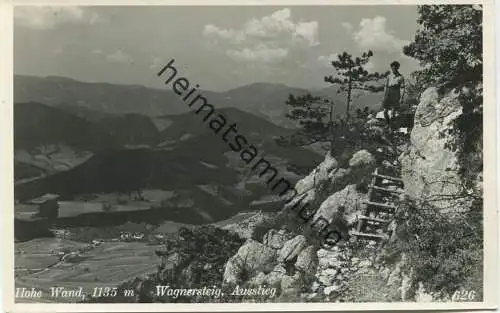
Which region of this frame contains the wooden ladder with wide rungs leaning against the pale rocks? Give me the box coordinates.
[351,168,403,242]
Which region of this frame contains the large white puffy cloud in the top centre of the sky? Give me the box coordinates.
[203,8,319,63]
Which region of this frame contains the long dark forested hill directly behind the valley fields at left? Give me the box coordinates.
[16,149,240,199]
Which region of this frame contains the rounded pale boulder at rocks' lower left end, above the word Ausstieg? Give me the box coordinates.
[223,239,276,284]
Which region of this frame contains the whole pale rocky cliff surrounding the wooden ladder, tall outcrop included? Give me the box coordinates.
[223,84,481,302]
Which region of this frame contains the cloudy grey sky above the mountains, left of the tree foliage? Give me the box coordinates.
[14,5,418,91]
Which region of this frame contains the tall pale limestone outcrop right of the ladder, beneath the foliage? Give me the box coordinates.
[400,88,476,210]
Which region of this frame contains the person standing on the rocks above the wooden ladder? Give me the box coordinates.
[382,61,405,128]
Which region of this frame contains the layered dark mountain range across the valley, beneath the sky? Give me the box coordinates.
[14,75,382,227]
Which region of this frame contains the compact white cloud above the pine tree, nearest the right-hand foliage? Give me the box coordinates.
[353,16,408,53]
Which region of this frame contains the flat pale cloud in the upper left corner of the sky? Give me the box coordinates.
[14,6,101,29]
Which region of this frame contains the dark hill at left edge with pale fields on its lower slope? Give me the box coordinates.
[14,102,161,182]
